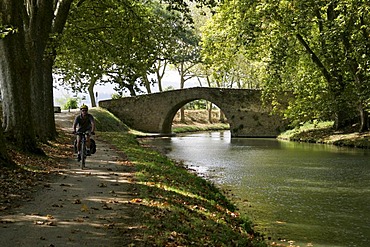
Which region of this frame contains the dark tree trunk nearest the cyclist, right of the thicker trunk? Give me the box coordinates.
[28,1,55,142]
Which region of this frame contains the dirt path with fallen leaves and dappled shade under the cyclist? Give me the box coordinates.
[0,112,139,247]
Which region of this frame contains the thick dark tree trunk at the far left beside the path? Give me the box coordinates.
[0,33,38,152]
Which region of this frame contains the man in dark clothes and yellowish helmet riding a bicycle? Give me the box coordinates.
[73,104,95,161]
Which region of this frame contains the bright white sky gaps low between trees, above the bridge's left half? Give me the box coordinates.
[54,70,204,106]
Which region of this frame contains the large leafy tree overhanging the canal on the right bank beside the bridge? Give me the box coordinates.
[208,0,369,129]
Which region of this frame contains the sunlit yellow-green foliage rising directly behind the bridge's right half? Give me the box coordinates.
[201,2,266,88]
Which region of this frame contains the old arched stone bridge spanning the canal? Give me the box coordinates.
[99,87,285,137]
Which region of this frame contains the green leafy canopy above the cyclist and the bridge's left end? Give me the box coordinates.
[56,0,201,95]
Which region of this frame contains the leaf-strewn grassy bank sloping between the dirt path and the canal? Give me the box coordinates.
[91,109,266,246]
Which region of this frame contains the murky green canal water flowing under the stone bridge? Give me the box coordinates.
[144,131,370,247]
